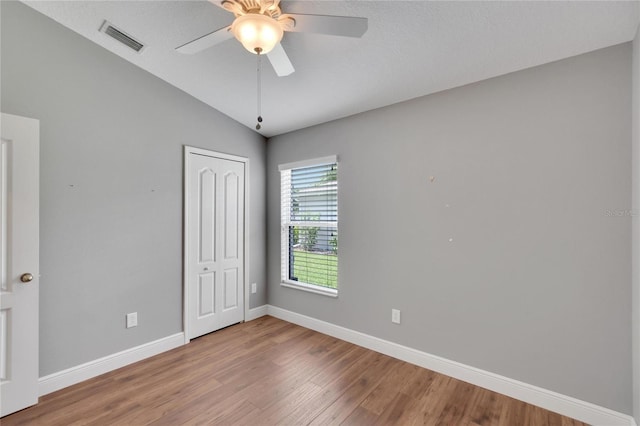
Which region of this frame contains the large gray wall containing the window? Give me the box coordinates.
[267,44,632,413]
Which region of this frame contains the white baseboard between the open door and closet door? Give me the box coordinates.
[38,333,184,396]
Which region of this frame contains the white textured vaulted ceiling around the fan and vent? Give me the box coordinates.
[25,0,638,136]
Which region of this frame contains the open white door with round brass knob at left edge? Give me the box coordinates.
[0,114,40,416]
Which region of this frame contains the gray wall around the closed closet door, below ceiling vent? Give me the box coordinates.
[1,1,266,375]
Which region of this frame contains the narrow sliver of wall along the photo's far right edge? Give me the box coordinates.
[631,20,640,424]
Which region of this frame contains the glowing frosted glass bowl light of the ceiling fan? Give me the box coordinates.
[231,13,284,54]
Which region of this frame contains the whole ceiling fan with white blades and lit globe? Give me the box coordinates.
[176,0,367,77]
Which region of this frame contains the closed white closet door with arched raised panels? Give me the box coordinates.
[185,148,245,339]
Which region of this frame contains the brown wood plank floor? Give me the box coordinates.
[1,317,583,426]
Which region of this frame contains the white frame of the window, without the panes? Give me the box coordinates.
[278,155,339,297]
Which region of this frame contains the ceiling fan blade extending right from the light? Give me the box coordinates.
[284,14,368,37]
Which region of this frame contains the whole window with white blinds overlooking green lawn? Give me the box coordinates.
[279,156,338,296]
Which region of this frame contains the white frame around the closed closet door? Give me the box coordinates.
[182,145,251,344]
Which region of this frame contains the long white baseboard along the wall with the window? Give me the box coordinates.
[267,305,636,426]
